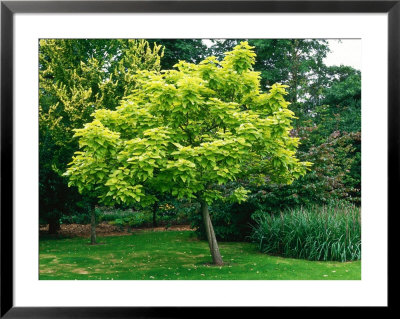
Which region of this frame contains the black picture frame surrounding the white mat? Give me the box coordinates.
[0,0,394,318]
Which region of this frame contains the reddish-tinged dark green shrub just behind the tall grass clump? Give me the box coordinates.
[247,128,361,212]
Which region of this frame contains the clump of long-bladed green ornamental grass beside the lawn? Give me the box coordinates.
[251,202,361,262]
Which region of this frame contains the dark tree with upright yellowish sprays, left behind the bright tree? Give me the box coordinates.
[39,39,162,233]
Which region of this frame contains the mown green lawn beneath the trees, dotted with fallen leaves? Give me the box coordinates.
[39,231,361,280]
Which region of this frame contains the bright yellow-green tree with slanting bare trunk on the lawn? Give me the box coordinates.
[65,42,309,265]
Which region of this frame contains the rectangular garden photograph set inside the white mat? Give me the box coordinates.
[38,38,364,281]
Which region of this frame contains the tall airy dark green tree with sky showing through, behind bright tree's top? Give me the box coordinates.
[211,39,335,119]
